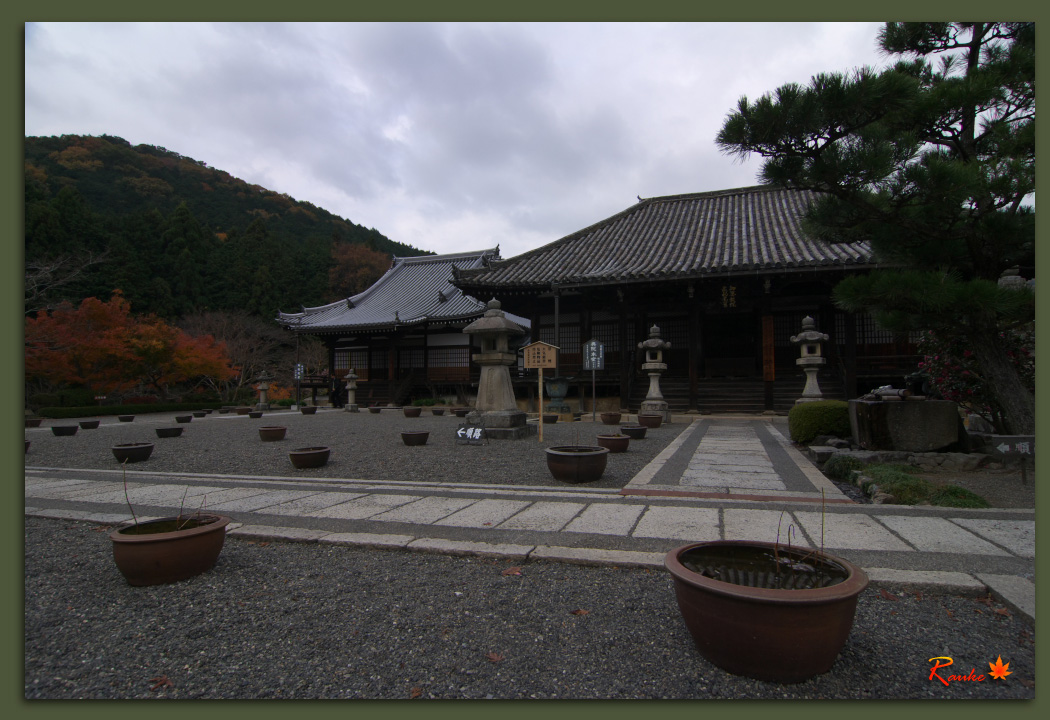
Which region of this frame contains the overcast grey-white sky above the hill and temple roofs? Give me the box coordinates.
[25,23,888,257]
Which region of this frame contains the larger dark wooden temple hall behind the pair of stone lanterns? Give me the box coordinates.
[453,186,918,412]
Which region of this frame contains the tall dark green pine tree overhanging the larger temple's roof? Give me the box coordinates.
[717,23,1035,433]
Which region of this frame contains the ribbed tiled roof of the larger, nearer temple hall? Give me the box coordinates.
[455,186,874,291]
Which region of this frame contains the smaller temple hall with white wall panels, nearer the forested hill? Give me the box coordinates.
[277,248,528,405]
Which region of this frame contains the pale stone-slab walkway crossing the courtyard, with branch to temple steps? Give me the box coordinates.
[25,418,1035,618]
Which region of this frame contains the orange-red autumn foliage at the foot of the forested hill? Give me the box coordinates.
[25,291,236,397]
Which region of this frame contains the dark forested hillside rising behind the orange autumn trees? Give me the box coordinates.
[24,135,426,320]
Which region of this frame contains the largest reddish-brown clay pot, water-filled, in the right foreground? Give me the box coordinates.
[664,541,867,682]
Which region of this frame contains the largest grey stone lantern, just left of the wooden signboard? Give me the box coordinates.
[463,298,529,439]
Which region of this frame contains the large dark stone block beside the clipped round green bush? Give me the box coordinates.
[849,400,959,452]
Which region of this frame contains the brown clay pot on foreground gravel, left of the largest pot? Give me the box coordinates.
[109,514,230,587]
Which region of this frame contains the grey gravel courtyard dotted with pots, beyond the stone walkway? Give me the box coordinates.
[25,409,689,488]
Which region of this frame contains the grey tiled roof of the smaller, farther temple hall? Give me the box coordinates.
[277,248,520,333]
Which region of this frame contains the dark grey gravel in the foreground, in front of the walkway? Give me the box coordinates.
[25,517,1035,699]
